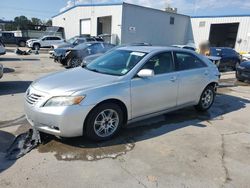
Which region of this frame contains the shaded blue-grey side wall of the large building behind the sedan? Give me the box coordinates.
[121,3,193,46]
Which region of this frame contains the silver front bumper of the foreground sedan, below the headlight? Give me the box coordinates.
[25,101,94,137]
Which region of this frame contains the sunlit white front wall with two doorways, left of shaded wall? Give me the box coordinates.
[52,4,122,40]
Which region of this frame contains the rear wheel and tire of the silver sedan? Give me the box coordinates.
[195,85,215,112]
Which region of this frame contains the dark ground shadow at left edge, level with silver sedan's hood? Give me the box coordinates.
[0,81,32,96]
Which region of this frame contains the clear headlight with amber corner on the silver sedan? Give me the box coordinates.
[44,96,85,107]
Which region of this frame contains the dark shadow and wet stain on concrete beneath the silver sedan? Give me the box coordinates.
[34,94,250,161]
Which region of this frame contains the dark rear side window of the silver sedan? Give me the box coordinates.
[175,52,206,70]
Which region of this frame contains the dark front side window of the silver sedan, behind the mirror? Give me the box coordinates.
[142,52,174,75]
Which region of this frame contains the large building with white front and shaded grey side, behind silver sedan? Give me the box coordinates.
[52,3,193,45]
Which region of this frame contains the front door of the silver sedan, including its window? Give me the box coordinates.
[131,52,178,118]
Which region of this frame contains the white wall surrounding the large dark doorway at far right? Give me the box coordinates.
[191,16,250,52]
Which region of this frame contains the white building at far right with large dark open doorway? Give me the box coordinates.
[191,15,250,52]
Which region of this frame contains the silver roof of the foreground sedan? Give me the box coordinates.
[118,46,190,53]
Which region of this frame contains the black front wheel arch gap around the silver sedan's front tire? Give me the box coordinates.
[83,98,128,132]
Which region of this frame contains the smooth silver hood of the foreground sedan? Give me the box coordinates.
[32,67,119,95]
